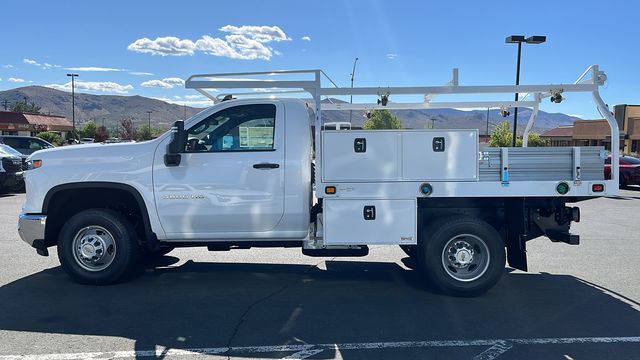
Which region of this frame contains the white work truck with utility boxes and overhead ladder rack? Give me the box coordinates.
[19,66,619,296]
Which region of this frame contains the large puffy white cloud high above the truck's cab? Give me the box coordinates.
[127,25,291,60]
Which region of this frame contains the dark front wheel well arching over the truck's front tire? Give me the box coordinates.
[43,185,153,246]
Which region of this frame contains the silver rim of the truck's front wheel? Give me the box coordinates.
[73,225,116,271]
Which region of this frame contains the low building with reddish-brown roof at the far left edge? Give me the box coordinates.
[0,111,73,139]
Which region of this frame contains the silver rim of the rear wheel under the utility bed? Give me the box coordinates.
[442,234,490,282]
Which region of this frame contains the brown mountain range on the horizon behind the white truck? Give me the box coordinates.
[0,86,579,134]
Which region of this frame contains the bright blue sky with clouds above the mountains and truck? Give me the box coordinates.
[0,0,640,119]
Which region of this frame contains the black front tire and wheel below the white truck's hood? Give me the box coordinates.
[58,209,140,285]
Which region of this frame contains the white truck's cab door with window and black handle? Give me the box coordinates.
[153,101,285,239]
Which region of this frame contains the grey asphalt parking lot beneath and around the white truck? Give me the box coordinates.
[0,188,640,360]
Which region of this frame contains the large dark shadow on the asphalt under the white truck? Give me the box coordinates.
[0,258,640,358]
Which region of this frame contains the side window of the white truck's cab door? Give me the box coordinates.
[186,104,276,152]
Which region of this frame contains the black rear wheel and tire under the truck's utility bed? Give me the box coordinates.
[418,218,506,297]
